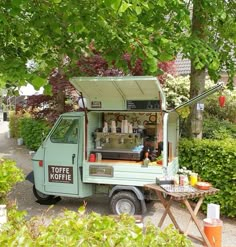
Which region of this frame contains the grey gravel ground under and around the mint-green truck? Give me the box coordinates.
[0,121,236,247]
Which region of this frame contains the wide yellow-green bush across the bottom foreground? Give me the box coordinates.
[0,207,193,247]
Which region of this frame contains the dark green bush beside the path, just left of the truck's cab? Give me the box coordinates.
[20,117,50,151]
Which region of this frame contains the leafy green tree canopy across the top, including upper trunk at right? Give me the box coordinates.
[0,0,236,136]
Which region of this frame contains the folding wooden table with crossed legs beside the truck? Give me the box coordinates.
[144,184,219,247]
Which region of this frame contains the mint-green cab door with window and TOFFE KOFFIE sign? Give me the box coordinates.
[44,117,80,195]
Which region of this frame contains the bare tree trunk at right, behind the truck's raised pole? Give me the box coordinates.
[187,0,207,138]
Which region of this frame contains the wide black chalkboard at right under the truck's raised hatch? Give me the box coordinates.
[127,100,161,111]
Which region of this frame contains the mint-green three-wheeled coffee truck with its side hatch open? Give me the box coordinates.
[32,76,222,214]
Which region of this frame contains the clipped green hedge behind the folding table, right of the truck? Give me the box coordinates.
[179,139,236,217]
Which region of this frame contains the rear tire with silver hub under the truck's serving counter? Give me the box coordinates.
[110,191,141,215]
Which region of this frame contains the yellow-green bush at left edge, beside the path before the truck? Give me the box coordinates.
[0,159,24,203]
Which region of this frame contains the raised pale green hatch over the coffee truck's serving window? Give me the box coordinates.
[70,76,166,110]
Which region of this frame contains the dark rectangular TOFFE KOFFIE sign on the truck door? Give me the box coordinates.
[48,166,73,184]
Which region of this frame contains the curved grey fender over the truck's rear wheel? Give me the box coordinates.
[109,185,147,214]
